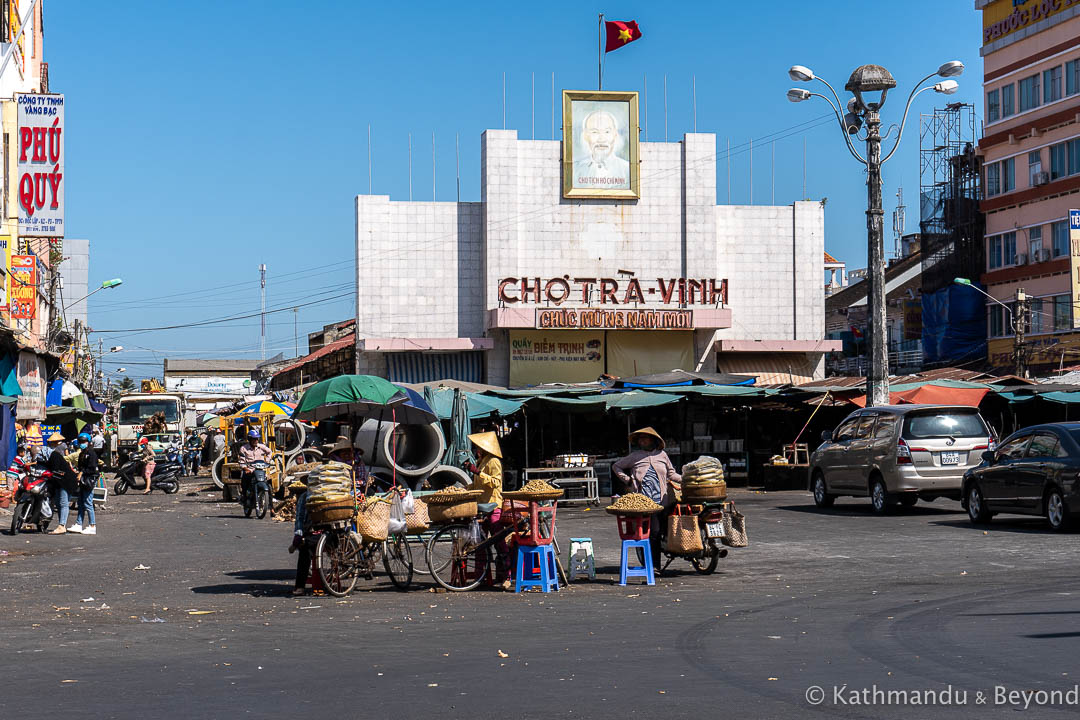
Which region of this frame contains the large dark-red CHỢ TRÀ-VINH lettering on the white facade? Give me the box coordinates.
[499,275,728,307]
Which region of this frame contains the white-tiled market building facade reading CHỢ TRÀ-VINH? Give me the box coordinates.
[355,93,840,386]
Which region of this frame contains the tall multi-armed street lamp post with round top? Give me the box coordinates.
[787,60,963,406]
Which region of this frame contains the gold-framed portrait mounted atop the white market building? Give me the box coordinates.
[563,90,642,200]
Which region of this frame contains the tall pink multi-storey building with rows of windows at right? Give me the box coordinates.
[975,0,1080,371]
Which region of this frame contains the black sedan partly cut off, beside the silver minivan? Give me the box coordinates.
[961,422,1080,531]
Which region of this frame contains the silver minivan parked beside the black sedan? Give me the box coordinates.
[810,405,994,514]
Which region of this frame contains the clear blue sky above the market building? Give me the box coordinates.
[45,0,982,377]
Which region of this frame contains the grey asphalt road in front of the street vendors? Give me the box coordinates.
[0,485,1080,719]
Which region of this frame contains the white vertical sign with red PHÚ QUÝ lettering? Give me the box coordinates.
[15,93,64,237]
